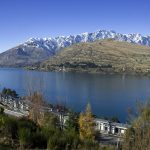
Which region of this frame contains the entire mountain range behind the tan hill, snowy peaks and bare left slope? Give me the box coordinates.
[0,30,150,67]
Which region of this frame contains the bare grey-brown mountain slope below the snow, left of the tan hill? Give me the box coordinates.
[0,45,51,67]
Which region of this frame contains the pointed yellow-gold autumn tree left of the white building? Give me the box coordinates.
[79,103,95,140]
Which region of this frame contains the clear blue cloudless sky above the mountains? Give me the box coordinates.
[0,0,150,52]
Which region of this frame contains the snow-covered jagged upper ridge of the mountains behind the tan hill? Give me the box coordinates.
[24,30,150,54]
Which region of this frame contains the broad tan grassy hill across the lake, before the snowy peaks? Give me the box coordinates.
[40,39,150,73]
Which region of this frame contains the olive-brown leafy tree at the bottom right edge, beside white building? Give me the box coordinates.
[123,101,150,150]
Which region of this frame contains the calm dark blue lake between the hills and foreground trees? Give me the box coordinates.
[0,68,150,122]
